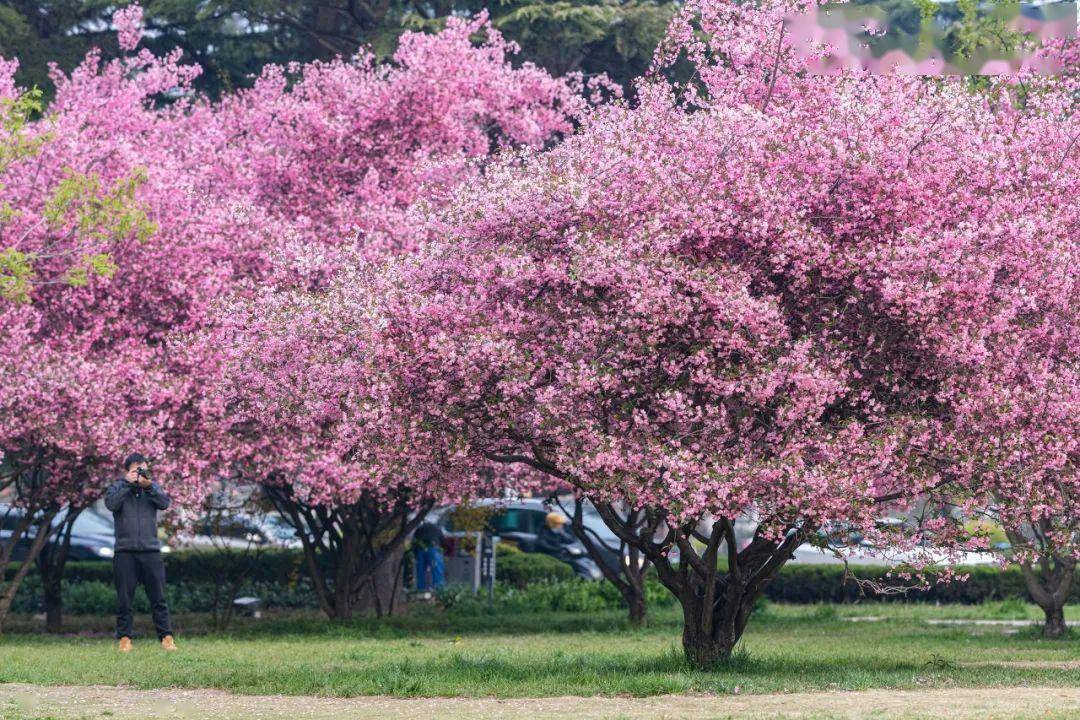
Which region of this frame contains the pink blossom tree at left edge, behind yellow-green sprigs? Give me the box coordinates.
[0,42,205,622]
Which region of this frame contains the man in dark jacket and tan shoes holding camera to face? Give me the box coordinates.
[105,452,176,652]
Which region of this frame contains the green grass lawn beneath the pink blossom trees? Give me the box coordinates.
[0,603,1080,697]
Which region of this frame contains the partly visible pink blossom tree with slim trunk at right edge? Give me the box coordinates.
[947,181,1080,637]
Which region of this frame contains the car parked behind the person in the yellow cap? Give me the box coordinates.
[427,498,617,580]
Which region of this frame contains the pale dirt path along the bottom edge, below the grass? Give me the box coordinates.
[0,684,1080,720]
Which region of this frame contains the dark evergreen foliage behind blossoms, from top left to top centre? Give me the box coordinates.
[0,0,675,102]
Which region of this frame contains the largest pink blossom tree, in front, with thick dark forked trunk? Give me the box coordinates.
[287,2,1078,666]
